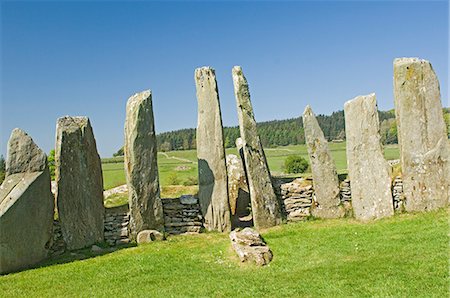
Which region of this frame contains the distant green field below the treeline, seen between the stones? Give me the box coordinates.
[102,143,399,189]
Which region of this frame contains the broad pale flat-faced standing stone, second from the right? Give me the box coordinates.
[344,93,394,220]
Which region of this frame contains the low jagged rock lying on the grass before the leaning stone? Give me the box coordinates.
[230,228,273,266]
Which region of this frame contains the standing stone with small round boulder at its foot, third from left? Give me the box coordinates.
[124,90,164,239]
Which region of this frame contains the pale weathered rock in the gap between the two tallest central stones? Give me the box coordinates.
[226,154,249,215]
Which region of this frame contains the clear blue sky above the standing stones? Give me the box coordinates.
[0,1,449,157]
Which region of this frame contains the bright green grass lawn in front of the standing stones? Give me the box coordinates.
[0,210,449,297]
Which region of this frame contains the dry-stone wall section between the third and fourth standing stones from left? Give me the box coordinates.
[162,195,203,235]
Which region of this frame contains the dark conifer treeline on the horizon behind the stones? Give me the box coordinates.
[114,110,414,156]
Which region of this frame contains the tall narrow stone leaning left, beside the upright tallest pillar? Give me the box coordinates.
[233,66,281,228]
